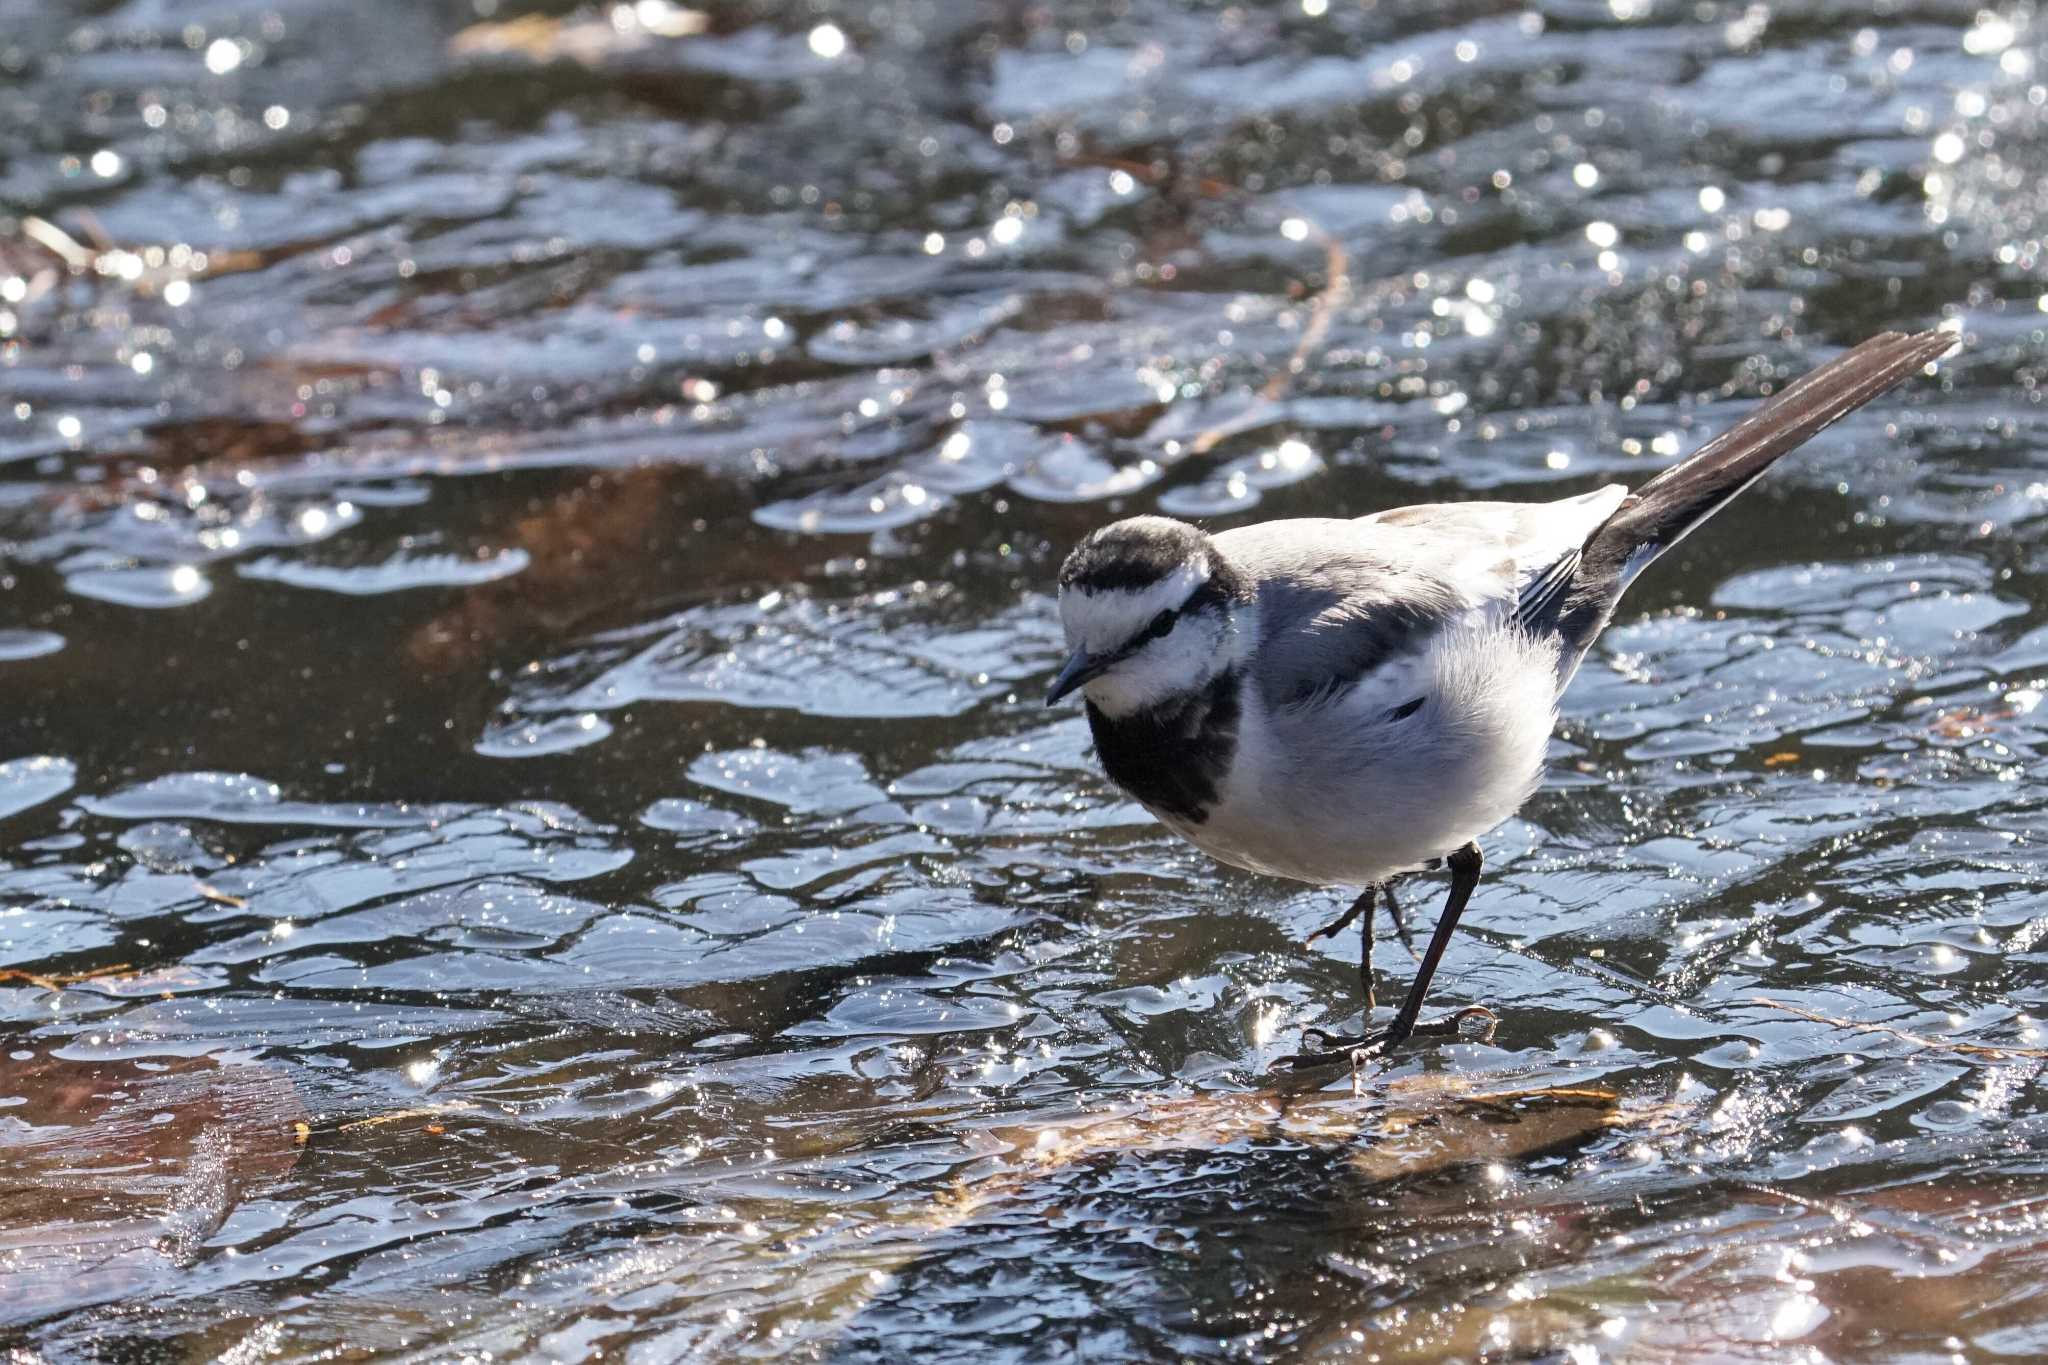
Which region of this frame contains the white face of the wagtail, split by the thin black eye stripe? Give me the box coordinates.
[1059,563,1231,716]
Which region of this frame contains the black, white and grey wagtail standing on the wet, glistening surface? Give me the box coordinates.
[1047,332,1956,1064]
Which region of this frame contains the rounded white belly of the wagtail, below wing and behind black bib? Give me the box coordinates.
[1167,622,1556,886]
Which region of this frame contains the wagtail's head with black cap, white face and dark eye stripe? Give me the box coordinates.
[1044,516,1247,716]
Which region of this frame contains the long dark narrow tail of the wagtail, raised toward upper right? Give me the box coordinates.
[1559,332,1958,649]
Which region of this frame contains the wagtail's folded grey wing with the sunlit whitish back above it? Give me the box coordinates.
[1217,485,1626,710]
